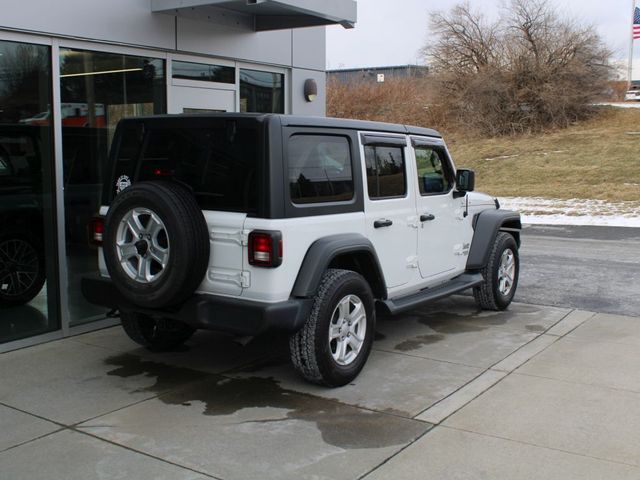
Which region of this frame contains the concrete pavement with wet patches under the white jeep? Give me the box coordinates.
[0,297,640,480]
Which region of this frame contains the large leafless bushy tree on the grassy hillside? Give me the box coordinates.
[423,0,611,135]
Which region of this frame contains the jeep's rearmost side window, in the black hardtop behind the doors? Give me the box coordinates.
[288,135,353,203]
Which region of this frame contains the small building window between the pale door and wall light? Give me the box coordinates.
[240,68,284,113]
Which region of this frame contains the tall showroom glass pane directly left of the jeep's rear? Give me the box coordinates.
[60,48,166,325]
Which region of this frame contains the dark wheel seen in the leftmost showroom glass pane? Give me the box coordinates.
[0,229,46,307]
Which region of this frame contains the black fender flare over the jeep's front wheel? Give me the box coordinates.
[467,209,522,270]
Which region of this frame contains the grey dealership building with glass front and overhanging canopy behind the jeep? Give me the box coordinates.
[0,0,356,351]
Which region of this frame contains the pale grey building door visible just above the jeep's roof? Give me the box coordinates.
[170,85,236,113]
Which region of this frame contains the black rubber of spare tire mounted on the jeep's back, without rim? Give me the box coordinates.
[103,181,209,308]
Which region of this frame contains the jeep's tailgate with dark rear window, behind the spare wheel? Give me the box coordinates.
[115,118,261,296]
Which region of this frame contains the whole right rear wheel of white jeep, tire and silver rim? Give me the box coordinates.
[289,269,375,387]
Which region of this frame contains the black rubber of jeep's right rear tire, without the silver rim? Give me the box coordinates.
[289,269,376,387]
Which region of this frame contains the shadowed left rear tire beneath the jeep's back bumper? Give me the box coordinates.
[120,312,196,352]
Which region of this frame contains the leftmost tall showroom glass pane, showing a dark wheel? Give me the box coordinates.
[0,41,59,343]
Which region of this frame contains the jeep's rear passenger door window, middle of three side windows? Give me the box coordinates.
[364,145,407,199]
